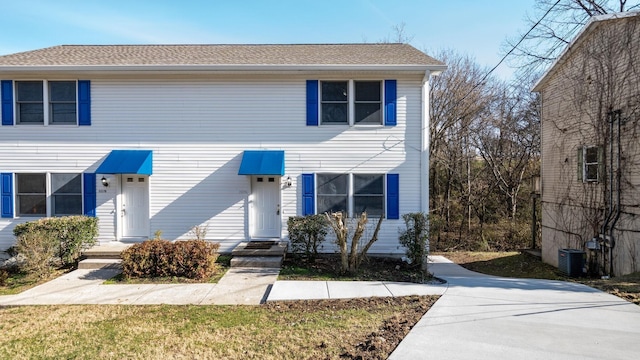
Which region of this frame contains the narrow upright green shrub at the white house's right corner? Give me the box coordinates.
[399,212,429,271]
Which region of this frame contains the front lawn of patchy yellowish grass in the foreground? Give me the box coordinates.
[0,296,437,359]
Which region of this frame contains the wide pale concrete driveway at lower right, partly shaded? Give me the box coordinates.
[390,256,640,360]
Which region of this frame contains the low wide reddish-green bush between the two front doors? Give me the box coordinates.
[122,240,220,279]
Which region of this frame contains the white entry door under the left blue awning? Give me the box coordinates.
[120,175,149,238]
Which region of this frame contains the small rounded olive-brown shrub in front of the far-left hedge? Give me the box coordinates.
[16,229,59,278]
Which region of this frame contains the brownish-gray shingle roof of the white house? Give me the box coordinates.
[0,44,444,67]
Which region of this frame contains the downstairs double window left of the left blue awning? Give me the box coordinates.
[16,173,82,216]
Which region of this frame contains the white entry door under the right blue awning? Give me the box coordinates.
[250,175,280,238]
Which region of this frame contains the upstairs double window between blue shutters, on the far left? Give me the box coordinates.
[15,81,77,125]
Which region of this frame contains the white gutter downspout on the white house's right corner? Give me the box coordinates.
[420,70,431,215]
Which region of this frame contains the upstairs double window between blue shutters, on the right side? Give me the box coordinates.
[320,80,383,125]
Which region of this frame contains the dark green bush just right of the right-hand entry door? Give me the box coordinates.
[287,215,328,259]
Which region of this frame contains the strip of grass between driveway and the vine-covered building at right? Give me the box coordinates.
[440,251,640,305]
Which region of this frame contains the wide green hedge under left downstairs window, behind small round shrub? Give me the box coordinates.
[13,215,98,266]
